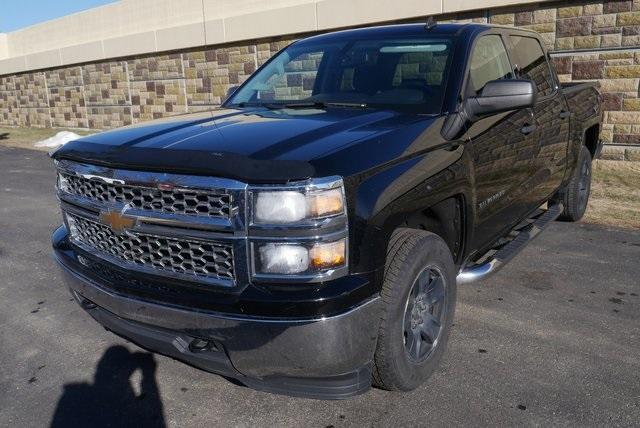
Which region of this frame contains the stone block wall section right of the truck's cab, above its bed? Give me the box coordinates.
[480,0,640,150]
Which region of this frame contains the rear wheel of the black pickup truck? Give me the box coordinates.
[560,146,591,221]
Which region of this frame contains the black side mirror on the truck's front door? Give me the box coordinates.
[464,80,537,121]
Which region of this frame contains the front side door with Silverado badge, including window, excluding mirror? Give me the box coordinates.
[465,34,536,248]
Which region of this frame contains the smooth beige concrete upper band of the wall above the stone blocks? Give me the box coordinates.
[0,0,556,75]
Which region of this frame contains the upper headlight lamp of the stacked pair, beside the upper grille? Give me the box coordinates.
[252,179,345,224]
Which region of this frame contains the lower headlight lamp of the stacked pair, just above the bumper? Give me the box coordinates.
[255,238,346,275]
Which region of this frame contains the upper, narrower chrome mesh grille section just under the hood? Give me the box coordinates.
[60,172,232,218]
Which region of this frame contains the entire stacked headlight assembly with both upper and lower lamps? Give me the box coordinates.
[249,177,348,282]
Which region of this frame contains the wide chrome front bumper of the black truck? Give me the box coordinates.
[55,246,381,399]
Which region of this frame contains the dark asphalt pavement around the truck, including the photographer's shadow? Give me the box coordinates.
[0,148,640,427]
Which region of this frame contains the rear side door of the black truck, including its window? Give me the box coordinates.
[508,34,569,208]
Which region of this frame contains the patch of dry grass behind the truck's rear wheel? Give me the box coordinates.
[584,160,640,229]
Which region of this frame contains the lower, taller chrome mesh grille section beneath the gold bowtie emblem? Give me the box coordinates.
[67,213,234,280]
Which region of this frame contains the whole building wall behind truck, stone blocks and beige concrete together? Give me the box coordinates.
[0,0,640,159]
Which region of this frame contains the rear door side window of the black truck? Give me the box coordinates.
[510,36,553,96]
